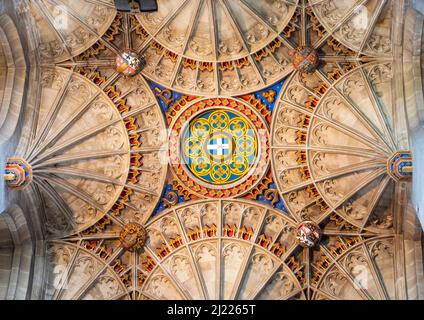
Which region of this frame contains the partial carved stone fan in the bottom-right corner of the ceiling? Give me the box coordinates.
[311,236,395,300]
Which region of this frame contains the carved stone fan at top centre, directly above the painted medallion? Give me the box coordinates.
[136,0,298,96]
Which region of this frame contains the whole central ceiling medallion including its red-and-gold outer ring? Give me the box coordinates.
[169,98,268,197]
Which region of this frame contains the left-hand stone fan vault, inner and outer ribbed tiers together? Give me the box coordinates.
[24,67,167,237]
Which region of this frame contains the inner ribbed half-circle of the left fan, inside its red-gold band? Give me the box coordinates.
[34,69,129,232]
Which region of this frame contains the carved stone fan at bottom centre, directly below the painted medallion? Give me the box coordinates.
[137,200,300,298]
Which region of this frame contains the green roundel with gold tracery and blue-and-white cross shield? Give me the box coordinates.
[181,107,258,185]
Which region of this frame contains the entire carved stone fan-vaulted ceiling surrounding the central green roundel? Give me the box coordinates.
[24,0,410,299]
